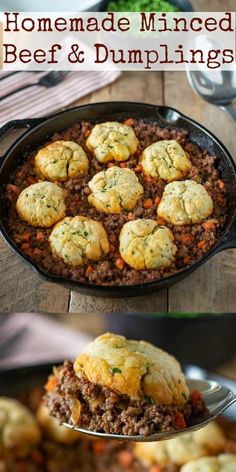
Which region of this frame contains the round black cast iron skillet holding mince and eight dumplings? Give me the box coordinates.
[0,102,236,297]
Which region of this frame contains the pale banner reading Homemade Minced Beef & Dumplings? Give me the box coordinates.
[1,12,235,71]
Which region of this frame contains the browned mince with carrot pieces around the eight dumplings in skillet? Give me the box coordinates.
[6,120,227,285]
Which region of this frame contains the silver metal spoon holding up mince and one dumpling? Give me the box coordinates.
[63,378,236,442]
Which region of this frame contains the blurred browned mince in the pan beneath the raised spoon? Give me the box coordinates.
[0,388,236,472]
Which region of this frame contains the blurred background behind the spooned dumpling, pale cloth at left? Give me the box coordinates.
[0,312,236,374]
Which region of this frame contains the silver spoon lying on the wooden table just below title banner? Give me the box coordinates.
[187,68,236,121]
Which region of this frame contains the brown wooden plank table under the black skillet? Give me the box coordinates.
[0,0,236,313]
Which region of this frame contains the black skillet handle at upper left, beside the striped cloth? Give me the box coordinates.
[0,118,47,161]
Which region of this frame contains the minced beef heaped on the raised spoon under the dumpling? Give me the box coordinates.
[46,361,208,436]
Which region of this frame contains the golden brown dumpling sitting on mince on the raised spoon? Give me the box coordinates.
[74,333,189,405]
